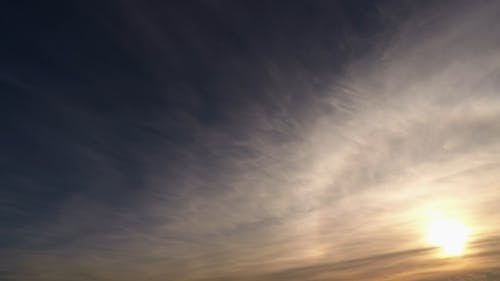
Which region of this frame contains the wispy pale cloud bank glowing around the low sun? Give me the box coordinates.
[4,2,500,281]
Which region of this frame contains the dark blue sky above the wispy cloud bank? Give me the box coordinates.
[0,1,382,230]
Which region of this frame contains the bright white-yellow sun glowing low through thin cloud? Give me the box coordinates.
[427,217,470,257]
